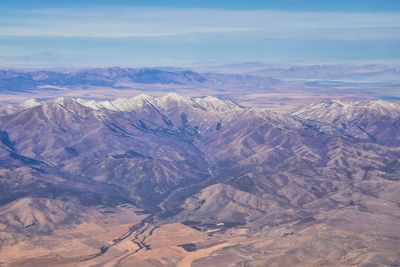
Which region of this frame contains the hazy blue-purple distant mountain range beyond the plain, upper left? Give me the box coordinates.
[0,68,279,93]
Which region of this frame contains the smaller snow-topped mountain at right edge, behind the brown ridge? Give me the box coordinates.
[291,100,400,145]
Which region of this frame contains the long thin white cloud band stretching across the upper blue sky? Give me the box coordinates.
[0,7,400,39]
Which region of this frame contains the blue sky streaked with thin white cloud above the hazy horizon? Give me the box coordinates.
[0,0,400,68]
